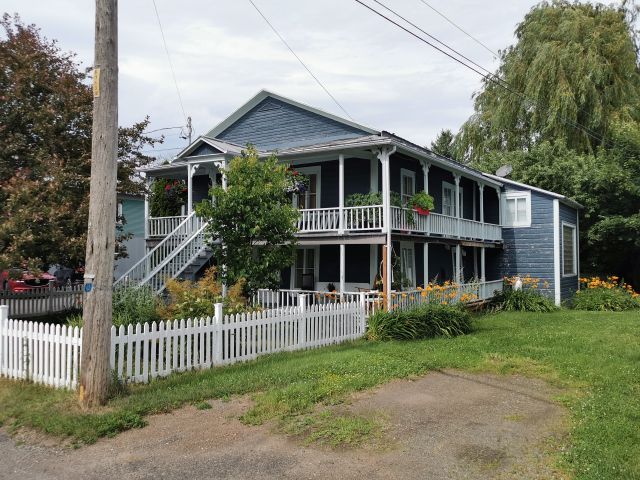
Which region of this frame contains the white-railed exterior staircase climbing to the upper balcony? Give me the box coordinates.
[113,212,212,293]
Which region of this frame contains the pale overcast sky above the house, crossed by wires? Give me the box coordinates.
[2,0,537,157]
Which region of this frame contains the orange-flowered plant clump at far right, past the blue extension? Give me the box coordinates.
[571,276,640,312]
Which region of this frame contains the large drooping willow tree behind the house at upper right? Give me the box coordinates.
[457,1,640,161]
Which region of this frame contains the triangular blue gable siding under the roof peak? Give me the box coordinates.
[218,98,368,150]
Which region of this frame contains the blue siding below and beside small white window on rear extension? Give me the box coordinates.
[500,187,554,298]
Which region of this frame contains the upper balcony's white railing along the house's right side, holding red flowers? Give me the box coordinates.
[391,207,502,241]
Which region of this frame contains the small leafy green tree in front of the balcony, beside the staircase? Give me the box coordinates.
[196,147,298,293]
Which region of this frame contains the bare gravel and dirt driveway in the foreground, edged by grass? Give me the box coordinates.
[0,371,566,480]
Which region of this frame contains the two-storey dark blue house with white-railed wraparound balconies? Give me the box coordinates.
[117,91,580,302]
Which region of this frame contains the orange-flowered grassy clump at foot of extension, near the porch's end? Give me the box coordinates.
[494,275,558,312]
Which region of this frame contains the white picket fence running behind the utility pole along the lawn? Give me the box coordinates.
[0,295,366,388]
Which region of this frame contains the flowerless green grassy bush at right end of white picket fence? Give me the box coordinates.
[367,303,471,340]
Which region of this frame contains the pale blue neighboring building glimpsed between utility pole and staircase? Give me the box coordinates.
[113,193,146,278]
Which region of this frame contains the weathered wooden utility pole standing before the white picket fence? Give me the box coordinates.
[80,0,118,407]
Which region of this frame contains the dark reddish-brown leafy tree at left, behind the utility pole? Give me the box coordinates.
[0,14,158,270]
